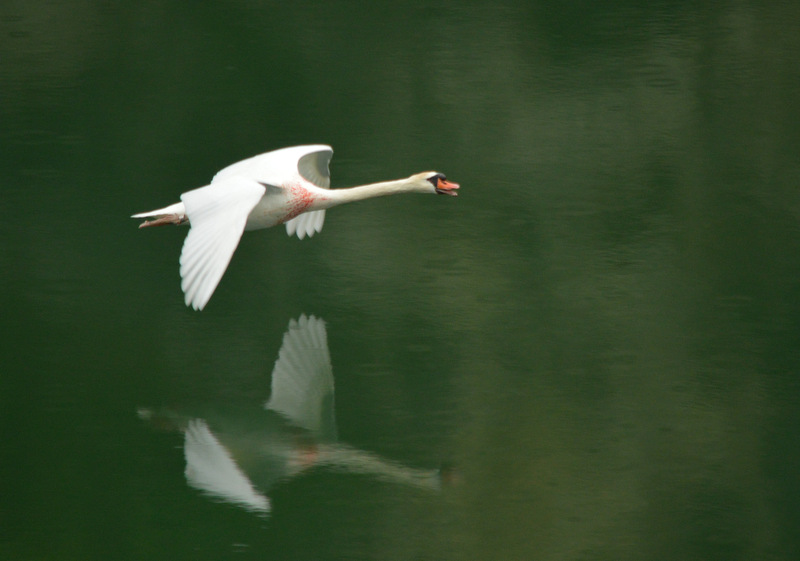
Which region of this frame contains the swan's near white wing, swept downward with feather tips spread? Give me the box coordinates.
[180,176,266,310]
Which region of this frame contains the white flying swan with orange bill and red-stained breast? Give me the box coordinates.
[132,144,459,310]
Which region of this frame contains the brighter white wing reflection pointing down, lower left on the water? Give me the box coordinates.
[183,419,270,512]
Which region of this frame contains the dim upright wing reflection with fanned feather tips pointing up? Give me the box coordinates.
[264,315,336,440]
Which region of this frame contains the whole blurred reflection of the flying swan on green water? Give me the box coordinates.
[138,315,451,514]
